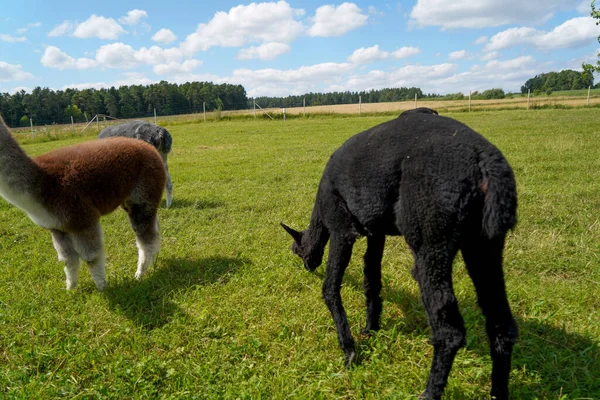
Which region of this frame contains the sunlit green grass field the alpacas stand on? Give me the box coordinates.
[0,108,600,399]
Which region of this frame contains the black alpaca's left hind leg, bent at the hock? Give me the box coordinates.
[413,244,466,399]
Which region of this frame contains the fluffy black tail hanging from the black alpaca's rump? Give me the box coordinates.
[479,148,517,239]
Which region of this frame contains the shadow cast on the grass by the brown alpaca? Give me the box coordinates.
[104,257,250,330]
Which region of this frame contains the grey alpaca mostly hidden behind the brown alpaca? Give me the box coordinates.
[98,121,173,208]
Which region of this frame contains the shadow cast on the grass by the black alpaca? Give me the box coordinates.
[340,274,600,399]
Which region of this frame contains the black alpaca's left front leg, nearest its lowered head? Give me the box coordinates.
[323,234,356,367]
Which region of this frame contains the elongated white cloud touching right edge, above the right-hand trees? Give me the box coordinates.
[484,17,600,51]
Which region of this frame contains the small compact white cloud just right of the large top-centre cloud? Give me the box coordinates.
[307,3,369,37]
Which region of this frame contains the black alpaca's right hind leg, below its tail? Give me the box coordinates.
[462,238,518,400]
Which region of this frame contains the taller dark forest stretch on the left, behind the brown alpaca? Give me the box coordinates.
[0,81,248,127]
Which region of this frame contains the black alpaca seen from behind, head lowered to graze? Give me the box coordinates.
[282,112,517,400]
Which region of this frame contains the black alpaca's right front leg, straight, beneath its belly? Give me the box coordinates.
[361,235,385,334]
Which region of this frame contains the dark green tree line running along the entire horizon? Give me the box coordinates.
[0,69,599,127]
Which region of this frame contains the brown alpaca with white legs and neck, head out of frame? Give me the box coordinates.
[0,118,166,290]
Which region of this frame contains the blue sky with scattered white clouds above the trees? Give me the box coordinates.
[0,0,600,97]
